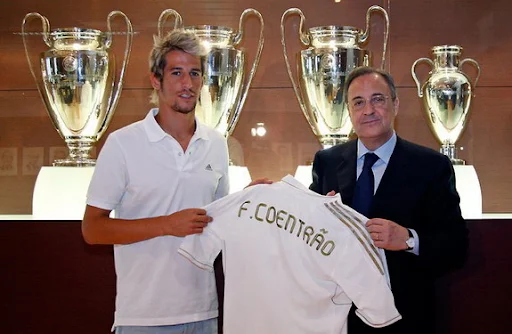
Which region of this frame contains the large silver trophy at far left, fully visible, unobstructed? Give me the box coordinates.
[21,11,133,167]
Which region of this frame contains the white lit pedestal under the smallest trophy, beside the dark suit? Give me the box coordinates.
[453,165,482,219]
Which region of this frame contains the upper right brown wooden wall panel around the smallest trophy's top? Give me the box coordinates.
[391,0,512,87]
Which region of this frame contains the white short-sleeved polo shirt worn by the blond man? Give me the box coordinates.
[87,109,229,326]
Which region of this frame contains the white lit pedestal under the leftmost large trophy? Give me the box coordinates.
[32,166,94,220]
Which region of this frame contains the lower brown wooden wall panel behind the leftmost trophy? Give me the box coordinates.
[0,89,150,214]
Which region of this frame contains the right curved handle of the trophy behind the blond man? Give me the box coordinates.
[228,8,264,134]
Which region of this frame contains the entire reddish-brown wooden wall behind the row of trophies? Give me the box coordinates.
[0,0,512,214]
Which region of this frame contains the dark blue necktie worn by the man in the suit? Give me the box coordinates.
[352,153,379,216]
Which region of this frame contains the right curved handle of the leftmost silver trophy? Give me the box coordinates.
[97,10,133,139]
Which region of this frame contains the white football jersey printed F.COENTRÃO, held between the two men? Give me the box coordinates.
[178,176,401,334]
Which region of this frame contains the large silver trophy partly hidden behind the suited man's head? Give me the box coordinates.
[281,5,389,148]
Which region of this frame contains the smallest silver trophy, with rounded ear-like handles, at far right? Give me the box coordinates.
[411,45,480,165]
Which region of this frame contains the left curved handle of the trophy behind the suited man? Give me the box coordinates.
[281,8,316,129]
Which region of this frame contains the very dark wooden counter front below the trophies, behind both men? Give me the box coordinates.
[0,219,512,334]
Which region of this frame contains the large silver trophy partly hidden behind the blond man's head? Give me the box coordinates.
[158,8,264,137]
